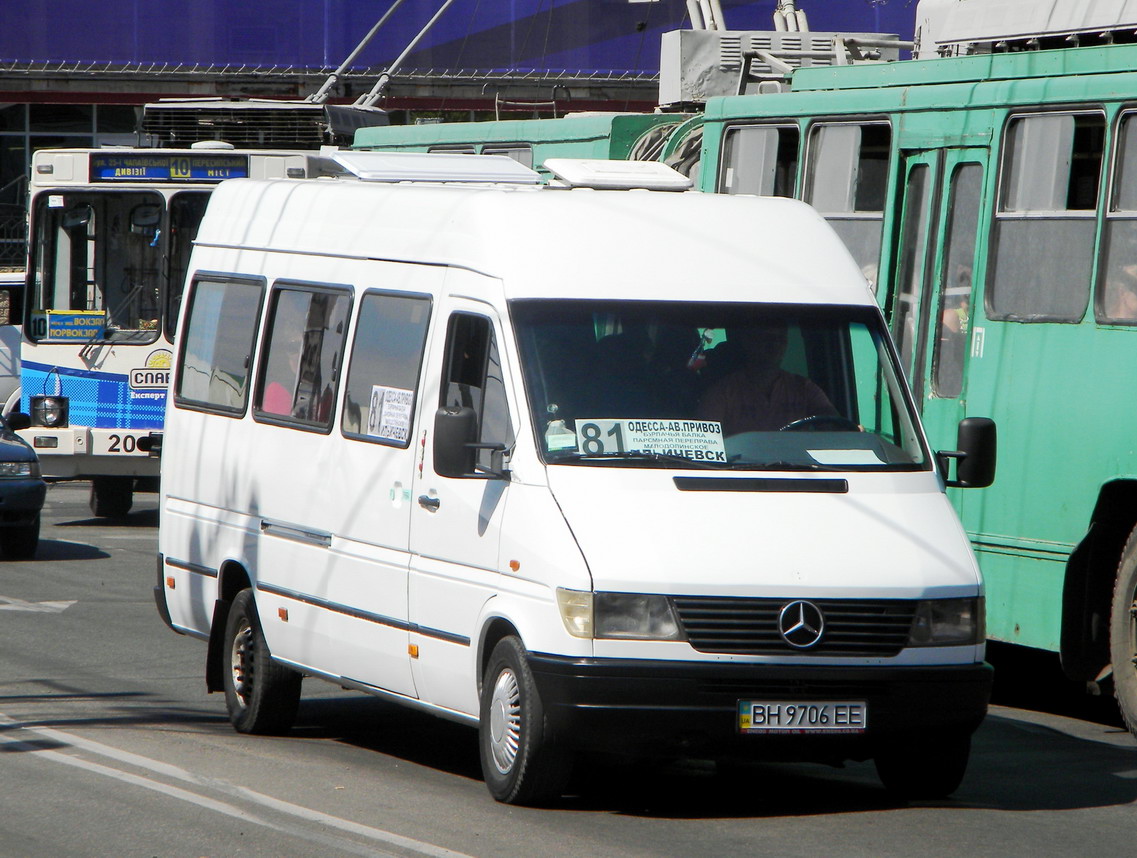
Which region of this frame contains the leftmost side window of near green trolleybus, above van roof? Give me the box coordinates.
[719,125,800,197]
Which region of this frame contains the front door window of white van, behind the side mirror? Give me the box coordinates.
[439,313,514,468]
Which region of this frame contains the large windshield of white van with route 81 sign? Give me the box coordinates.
[511,300,930,470]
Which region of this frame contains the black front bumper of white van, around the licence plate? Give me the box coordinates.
[529,653,994,761]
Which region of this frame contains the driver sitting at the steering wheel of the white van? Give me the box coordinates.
[699,323,837,436]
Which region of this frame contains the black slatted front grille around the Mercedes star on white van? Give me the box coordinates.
[672,595,916,657]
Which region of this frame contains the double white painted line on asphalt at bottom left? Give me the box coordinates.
[0,713,471,858]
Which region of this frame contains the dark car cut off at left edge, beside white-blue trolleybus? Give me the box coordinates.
[0,414,48,560]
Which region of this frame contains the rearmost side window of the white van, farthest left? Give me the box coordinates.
[175,280,264,414]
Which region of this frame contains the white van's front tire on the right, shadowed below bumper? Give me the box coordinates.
[873,735,971,799]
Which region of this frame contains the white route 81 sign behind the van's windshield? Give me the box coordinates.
[576,419,727,463]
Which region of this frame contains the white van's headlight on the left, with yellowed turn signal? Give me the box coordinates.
[557,590,683,641]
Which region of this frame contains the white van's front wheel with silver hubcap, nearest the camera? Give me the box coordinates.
[478,636,572,805]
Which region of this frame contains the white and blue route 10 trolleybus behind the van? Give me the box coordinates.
[19,143,327,516]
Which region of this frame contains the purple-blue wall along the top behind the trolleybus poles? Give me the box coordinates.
[0,0,915,72]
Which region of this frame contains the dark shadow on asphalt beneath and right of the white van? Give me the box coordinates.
[281,697,1137,819]
